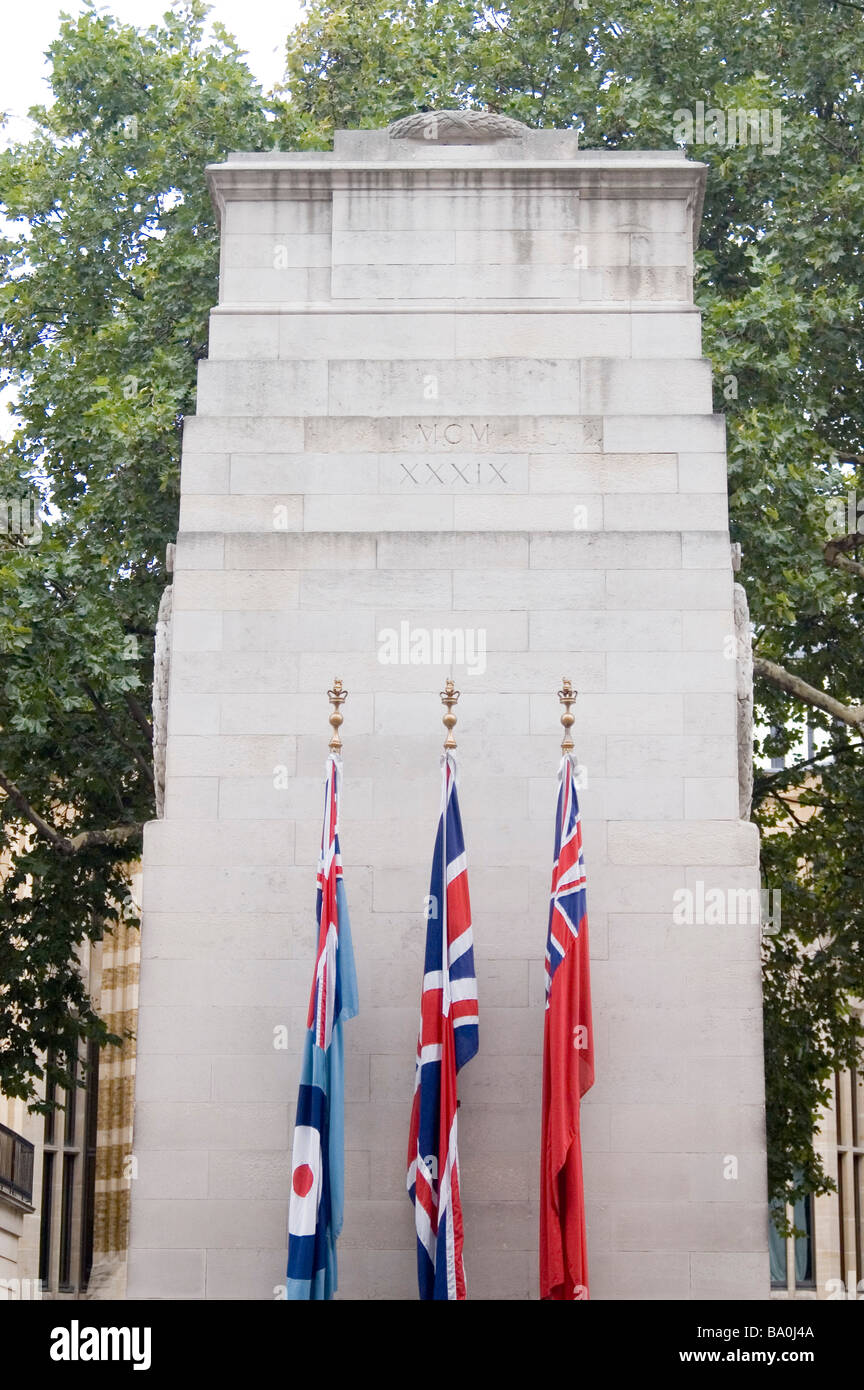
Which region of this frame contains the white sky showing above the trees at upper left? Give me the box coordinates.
[0,0,303,143]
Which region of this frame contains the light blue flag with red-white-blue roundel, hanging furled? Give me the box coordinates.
[286,753,357,1300]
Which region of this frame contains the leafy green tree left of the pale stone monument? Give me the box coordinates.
[0,0,272,1101]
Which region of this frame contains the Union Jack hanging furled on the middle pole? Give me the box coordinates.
[408,753,479,1300]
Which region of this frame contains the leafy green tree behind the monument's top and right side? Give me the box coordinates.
[281,0,864,1200]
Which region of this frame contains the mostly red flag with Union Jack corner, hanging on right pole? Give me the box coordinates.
[540,756,595,1300]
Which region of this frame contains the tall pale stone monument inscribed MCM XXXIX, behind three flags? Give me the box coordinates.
[129,113,768,1298]
